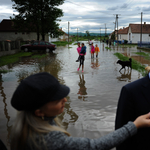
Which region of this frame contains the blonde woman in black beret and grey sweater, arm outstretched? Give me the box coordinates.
[11,73,150,150]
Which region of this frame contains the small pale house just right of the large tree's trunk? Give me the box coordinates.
[50,28,71,42]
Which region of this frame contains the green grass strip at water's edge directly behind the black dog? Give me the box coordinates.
[114,53,147,76]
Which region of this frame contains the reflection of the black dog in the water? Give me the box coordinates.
[117,69,132,82]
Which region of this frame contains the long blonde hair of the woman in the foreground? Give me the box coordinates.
[11,111,70,150]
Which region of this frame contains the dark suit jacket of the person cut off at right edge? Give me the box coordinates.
[115,75,150,150]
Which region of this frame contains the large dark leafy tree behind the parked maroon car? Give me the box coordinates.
[11,0,64,40]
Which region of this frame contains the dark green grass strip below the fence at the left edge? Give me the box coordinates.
[0,52,33,67]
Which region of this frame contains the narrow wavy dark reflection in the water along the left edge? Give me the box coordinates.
[0,74,12,145]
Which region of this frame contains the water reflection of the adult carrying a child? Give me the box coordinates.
[77,74,87,101]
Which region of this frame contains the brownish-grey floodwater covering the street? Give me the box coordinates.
[0,42,150,148]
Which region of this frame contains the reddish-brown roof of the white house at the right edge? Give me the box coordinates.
[129,23,150,34]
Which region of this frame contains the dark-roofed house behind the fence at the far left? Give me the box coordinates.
[0,19,49,41]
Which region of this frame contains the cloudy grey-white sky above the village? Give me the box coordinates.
[0,0,150,33]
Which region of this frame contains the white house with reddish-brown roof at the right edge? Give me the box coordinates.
[128,22,150,43]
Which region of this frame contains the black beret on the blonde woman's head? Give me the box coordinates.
[11,72,70,111]
